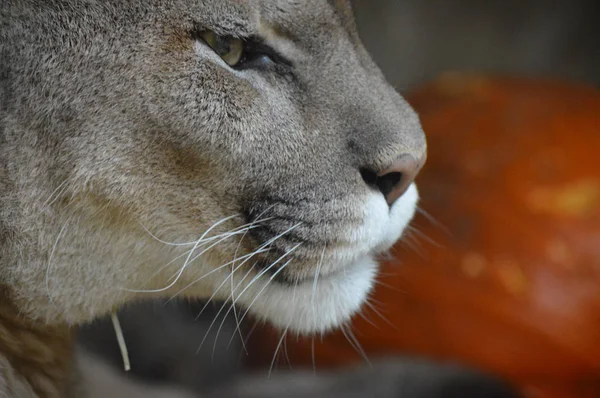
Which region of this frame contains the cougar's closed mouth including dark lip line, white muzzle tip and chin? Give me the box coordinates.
[227,184,418,334]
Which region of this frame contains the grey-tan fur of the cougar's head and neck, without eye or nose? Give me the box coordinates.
[0,0,426,397]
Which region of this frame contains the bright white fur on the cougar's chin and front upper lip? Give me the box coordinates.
[232,184,419,334]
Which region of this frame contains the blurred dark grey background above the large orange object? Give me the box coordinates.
[353,0,600,91]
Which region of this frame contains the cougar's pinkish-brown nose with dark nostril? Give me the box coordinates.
[360,153,427,206]
